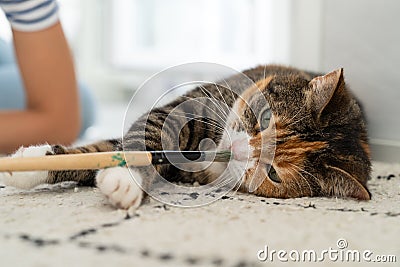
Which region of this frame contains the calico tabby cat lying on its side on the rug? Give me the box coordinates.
[3,65,371,209]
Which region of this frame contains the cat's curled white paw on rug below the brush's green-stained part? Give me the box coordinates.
[96,167,143,209]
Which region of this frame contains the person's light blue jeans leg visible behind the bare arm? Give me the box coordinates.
[0,64,96,136]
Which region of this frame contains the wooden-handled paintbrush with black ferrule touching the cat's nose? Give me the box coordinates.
[0,151,232,172]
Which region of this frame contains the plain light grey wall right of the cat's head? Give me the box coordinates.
[321,0,400,162]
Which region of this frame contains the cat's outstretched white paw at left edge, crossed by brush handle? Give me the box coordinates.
[0,145,52,189]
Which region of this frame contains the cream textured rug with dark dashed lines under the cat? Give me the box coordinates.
[0,163,400,267]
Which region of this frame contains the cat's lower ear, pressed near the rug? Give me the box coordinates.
[327,166,371,200]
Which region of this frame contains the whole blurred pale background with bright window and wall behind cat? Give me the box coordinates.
[0,0,400,161]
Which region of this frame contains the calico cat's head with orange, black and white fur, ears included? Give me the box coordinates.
[212,70,370,199]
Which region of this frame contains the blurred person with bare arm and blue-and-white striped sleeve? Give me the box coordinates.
[0,0,93,154]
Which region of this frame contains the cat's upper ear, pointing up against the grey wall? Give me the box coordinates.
[307,68,344,117]
